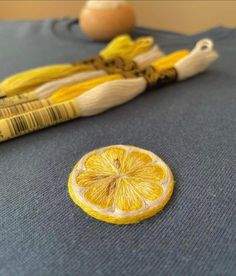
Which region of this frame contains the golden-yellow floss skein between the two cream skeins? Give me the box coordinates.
[0,50,189,119]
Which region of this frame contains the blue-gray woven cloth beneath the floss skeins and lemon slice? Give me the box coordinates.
[0,18,236,276]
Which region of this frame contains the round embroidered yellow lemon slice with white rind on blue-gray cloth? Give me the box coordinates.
[68,145,174,224]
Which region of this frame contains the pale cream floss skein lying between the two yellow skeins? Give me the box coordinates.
[0,45,164,108]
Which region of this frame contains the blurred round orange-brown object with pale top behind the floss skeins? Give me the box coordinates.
[80,0,135,40]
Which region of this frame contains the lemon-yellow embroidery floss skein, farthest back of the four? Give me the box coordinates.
[0,35,153,97]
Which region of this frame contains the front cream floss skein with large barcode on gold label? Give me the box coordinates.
[0,39,218,141]
